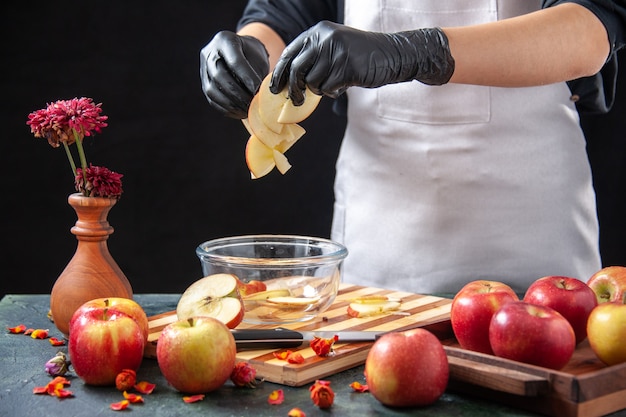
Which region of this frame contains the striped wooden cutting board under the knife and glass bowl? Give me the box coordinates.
[145,284,452,386]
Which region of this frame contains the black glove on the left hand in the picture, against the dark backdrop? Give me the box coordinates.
[200,31,270,119]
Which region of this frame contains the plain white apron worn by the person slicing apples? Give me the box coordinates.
[332,0,600,293]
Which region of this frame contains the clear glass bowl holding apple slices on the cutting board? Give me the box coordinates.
[196,235,348,325]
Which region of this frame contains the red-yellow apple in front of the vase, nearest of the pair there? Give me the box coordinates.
[68,306,145,385]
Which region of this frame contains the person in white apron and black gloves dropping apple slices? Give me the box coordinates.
[201,0,625,293]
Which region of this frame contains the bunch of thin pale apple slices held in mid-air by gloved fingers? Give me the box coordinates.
[242,74,322,179]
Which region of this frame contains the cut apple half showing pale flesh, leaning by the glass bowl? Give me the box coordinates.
[176,274,244,329]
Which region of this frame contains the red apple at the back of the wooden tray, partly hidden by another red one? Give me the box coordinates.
[523,275,598,344]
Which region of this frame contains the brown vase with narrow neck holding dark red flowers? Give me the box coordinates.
[50,193,133,337]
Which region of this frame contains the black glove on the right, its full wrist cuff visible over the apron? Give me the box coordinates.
[270,21,454,105]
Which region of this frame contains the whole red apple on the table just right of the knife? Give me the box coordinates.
[365,329,449,407]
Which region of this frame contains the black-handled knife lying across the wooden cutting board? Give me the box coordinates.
[231,327,386,350]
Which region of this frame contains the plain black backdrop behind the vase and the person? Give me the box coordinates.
[0,0,626,296]
